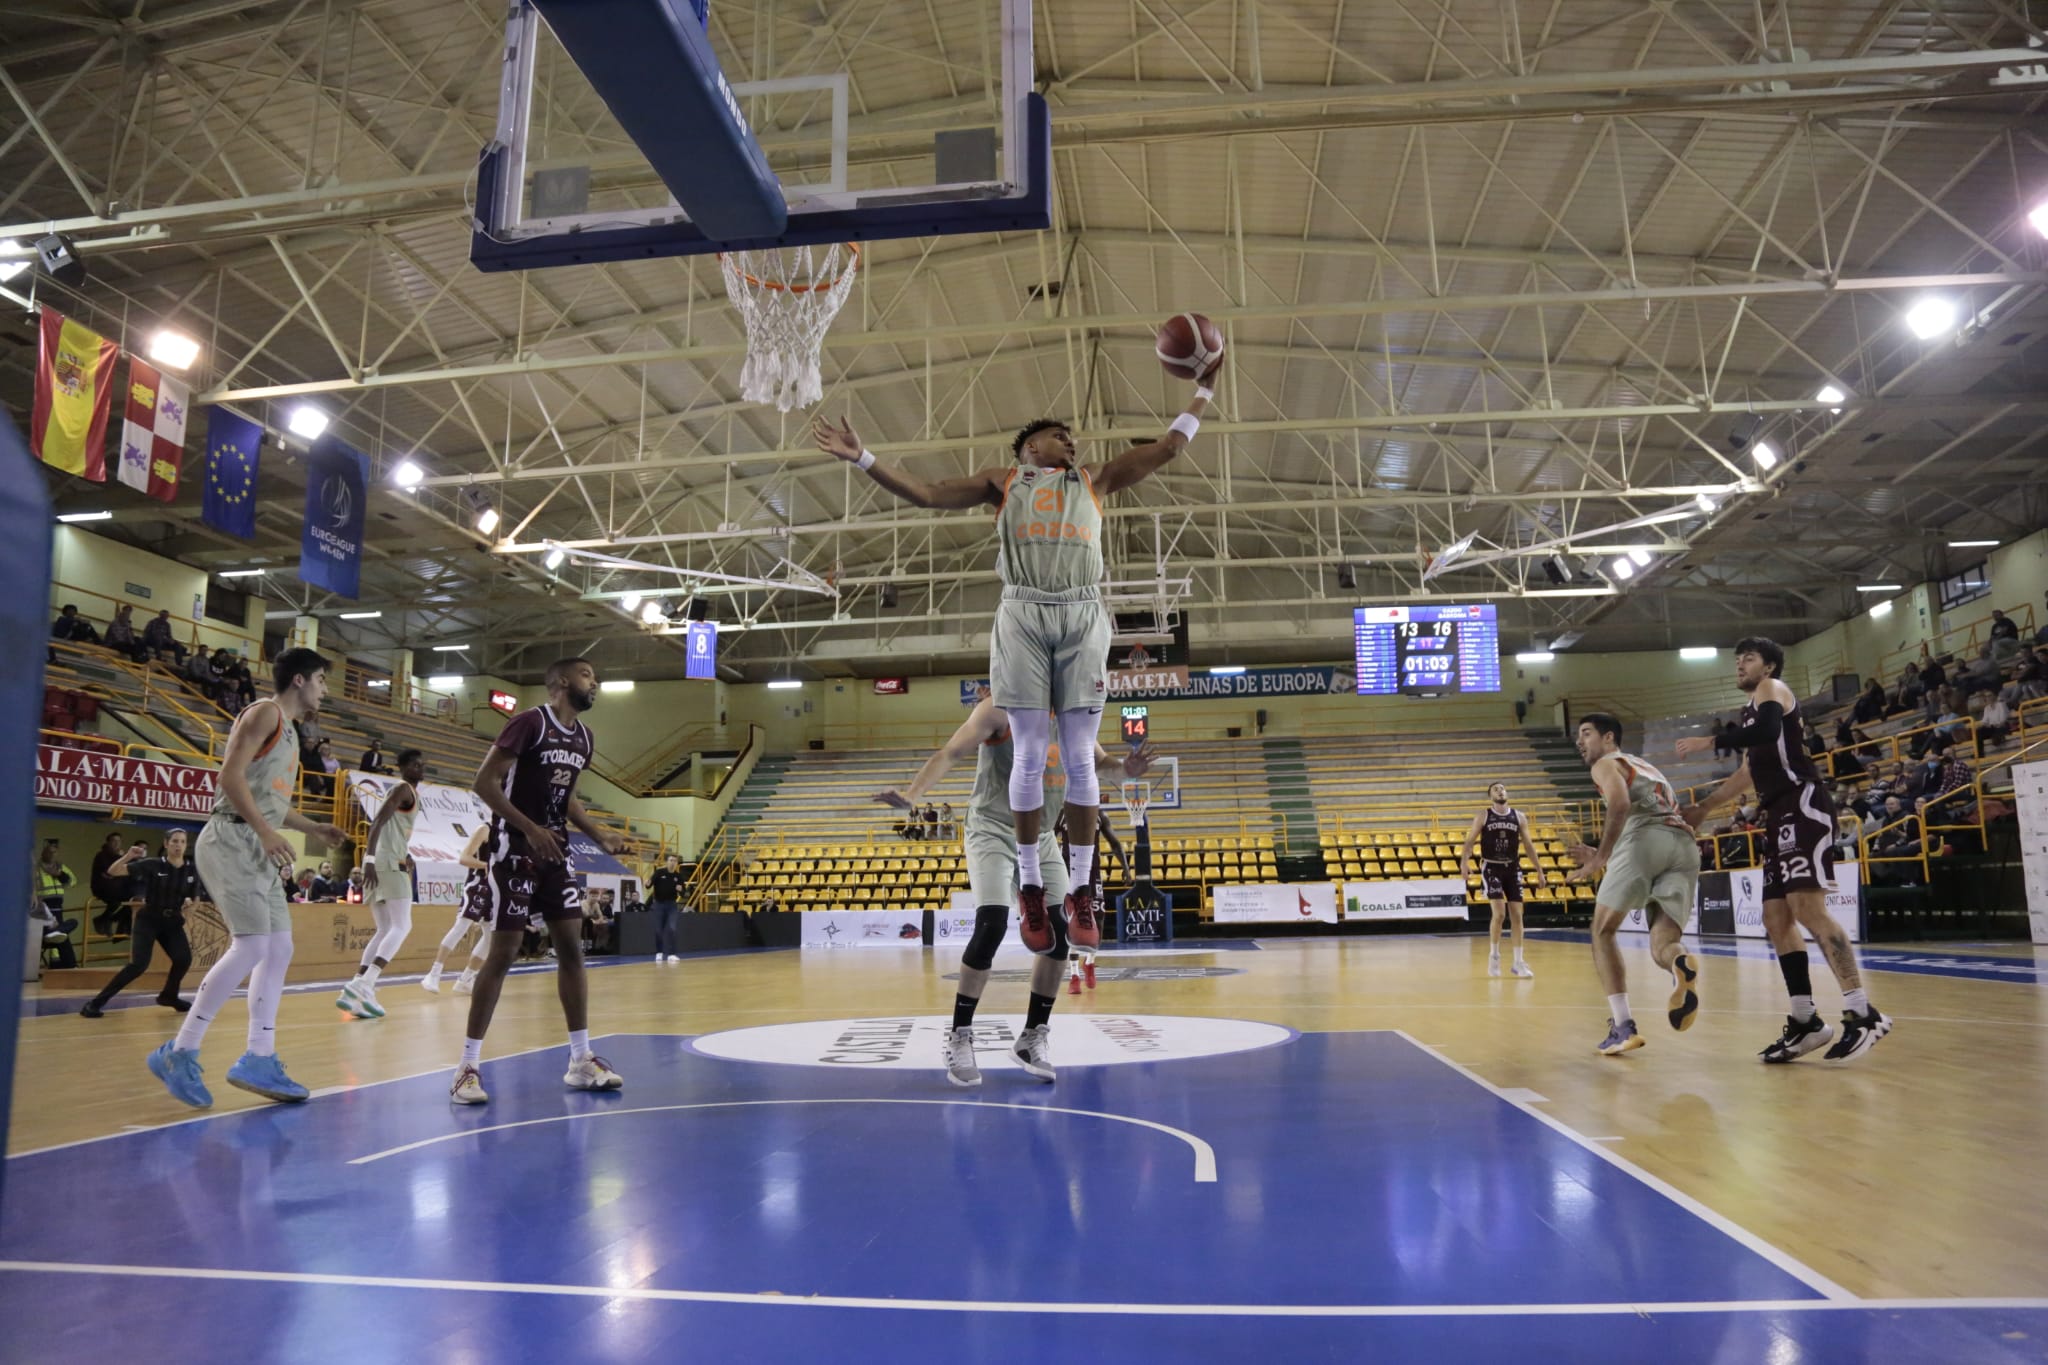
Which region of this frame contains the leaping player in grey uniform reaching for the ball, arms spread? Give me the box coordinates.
[813,368,1221,954]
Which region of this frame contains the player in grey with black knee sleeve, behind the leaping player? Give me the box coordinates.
[874,696,1153,1085]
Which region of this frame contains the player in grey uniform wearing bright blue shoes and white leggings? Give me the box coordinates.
[150,649,346,1109]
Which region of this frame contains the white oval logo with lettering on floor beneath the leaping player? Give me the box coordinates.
[690,1013,1294,1070]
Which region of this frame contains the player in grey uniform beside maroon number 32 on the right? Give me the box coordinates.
[1571,712,1700,1056]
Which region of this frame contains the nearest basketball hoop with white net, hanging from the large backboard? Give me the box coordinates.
[719,244,860,411]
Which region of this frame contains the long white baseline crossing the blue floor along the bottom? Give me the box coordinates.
[0,1261,2048,1318]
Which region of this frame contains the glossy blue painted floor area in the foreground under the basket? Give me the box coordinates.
[0,1033,2048,1365]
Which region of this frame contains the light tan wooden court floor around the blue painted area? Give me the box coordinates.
[8,935,2048,1297]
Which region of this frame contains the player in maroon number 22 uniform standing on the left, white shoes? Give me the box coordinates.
[449,659,625,1105]
